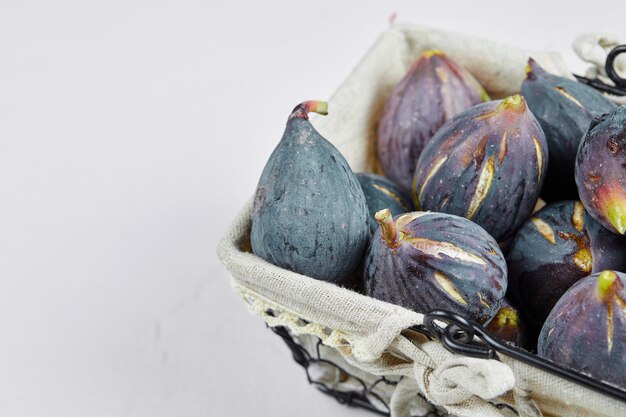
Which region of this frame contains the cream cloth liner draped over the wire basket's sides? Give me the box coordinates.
[218,25,626,417]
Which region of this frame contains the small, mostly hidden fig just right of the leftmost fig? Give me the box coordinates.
[356,172,411,234]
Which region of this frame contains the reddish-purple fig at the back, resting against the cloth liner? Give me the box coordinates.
[377,51,489,192]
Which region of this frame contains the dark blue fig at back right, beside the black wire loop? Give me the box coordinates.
[522,59,615,201]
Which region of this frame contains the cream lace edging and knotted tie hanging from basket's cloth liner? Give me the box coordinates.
[232,282,541,417]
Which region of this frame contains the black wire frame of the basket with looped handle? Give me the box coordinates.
[268,45,626,417]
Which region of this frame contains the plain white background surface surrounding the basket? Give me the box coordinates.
[0,0,626,417]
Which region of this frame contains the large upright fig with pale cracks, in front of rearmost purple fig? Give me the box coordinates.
[413,95,548,242]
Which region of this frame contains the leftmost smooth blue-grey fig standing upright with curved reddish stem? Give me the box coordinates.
[250,101,370,283]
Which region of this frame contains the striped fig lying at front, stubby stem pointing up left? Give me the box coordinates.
[363,209,507,323]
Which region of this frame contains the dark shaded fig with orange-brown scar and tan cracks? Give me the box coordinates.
[507,200,626,334]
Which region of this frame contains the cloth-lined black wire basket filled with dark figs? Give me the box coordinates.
[218,25,626,417]
